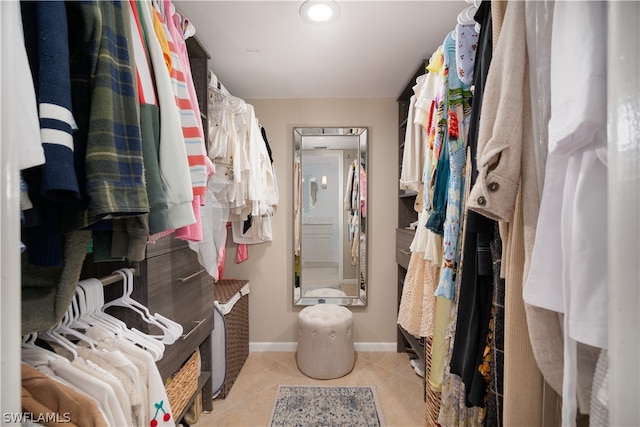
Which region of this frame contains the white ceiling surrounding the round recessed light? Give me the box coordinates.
[173,0,468,99]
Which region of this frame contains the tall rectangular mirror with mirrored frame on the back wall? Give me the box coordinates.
[293,127,367,306]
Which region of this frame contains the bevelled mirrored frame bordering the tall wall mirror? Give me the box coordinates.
[291,126,370,307]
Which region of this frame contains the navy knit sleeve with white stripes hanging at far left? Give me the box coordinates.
[21,2,80,267]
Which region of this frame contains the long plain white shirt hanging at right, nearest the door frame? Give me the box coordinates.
[524,2,608,425]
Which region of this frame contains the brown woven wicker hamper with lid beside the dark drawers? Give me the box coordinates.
[214,279,249,398]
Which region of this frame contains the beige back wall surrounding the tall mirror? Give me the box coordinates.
[223,98,398,343]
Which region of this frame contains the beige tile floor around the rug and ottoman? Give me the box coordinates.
[192,352,426,427]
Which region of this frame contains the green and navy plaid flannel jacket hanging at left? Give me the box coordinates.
[66,1,149,228]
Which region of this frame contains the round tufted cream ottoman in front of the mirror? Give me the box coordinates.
[296,304,355,380]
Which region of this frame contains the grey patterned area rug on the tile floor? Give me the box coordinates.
[269,385,386,427]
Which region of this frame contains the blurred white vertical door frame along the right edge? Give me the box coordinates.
[607,2,640,426]
